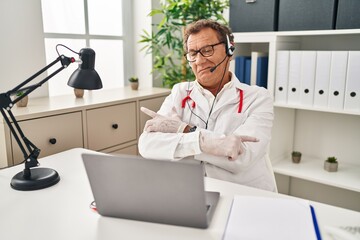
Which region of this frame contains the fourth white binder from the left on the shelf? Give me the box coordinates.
[314,51,331,107]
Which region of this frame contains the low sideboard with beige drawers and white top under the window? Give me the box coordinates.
[0,87,170,167]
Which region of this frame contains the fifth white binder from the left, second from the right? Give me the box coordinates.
[328,51,348,110]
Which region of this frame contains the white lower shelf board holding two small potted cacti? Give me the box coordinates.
[273,156,360,192]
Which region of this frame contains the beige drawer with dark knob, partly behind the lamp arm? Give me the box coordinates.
[11,112,84,164]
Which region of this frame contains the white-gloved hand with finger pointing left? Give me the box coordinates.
[140,107,187,133]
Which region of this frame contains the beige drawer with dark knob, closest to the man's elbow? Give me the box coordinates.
[86,102,136,151]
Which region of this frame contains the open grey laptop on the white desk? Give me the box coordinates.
[82,154,220,228]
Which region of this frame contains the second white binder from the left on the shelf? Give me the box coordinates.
[287,51,301,105]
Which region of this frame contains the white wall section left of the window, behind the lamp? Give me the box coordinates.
[0,0,48,97]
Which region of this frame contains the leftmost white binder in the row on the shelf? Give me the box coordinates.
[275,51,290,103]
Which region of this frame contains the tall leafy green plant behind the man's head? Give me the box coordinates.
[139,0,230,88]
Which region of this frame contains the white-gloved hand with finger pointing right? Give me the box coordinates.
[200,131,259,160]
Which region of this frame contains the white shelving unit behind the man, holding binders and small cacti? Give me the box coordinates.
[234,29,360,211]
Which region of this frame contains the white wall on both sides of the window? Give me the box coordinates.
[0,0,153,97]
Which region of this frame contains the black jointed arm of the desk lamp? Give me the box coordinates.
[0,55,75,172]
